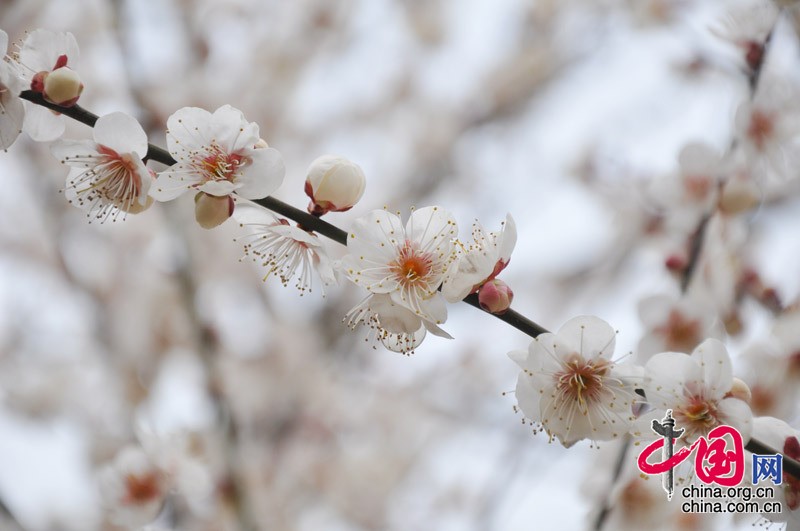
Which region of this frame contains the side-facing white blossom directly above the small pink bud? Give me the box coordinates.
[442,214,517,302]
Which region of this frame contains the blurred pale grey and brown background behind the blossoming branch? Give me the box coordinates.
[0,0,800,530]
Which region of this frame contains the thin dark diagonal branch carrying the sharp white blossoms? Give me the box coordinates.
[19,90,800,479]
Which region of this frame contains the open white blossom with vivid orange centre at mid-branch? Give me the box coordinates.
[342,206,458,325]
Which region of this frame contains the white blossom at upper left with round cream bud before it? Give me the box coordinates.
[12,29,83,142]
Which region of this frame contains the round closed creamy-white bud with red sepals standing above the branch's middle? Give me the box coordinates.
[306,155,366,216]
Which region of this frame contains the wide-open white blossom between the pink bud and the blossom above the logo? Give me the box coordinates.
[509,316,639,447]
